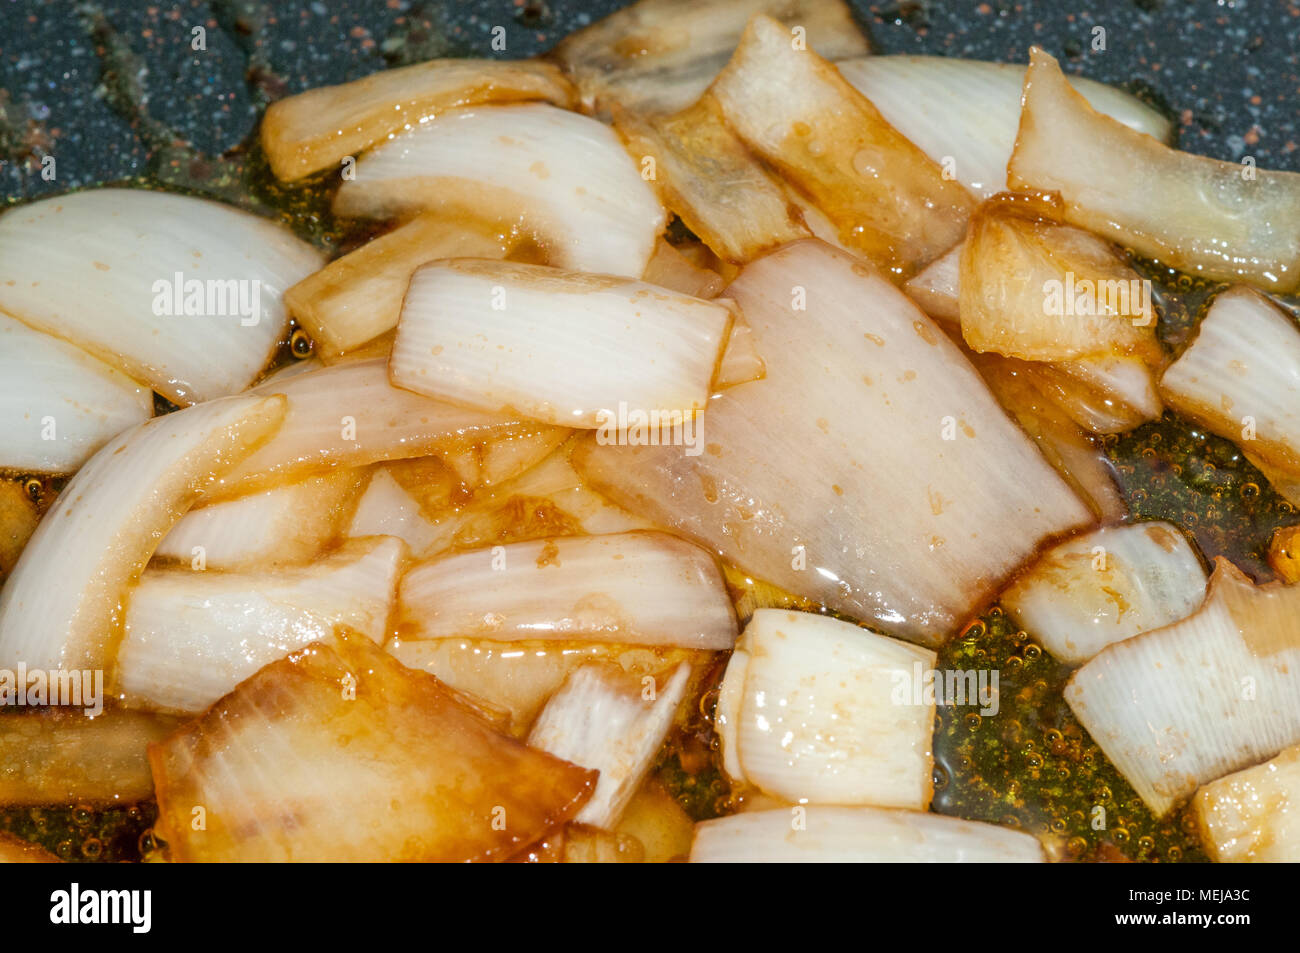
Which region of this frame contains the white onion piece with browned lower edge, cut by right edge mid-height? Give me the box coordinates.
[1160,287,1300,476]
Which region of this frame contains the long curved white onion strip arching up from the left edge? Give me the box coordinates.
[0,397,285,670]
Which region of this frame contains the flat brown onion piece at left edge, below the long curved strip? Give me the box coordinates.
[0,699,178,807]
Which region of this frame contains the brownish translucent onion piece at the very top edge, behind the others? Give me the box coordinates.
[551,0,867,116]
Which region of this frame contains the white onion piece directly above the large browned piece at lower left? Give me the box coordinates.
[122,537,406,712]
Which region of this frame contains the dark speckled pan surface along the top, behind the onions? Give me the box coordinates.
[0,0,1300,202]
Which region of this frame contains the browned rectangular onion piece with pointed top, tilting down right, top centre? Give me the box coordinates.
[710,16,974,273]
